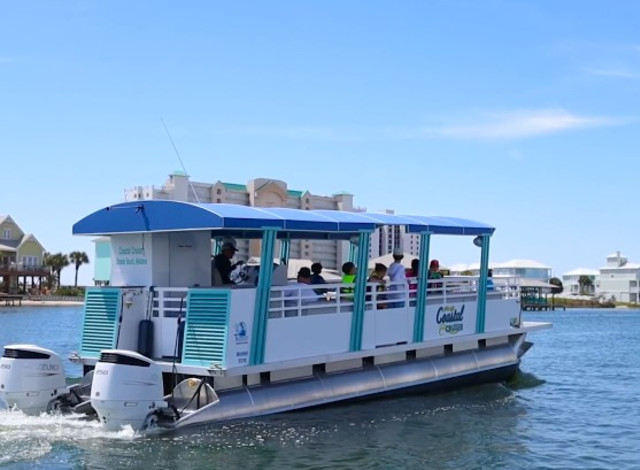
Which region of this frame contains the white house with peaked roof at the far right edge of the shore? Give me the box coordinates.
[595,251,640,302]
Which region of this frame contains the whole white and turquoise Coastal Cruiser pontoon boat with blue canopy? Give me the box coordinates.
[0,200,551,430]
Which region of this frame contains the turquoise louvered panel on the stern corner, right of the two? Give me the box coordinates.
[182,289,231,367]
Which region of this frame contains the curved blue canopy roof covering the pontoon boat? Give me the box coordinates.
[73,200,494,239]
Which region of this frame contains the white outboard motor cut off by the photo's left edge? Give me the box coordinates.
[0,344,67,414]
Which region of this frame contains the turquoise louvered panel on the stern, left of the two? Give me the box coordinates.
[80,287,122,358]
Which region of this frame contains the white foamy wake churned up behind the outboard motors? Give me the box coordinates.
[0,409,139,466]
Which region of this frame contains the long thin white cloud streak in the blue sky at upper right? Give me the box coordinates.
[424,109,619,139]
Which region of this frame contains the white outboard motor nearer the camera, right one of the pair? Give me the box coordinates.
[91,349,167,431]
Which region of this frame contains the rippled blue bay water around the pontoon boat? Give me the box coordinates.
[0,307,640,470]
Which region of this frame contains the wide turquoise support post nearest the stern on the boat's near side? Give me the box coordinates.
[250,229,277,365]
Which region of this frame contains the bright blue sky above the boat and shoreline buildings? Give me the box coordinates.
[0,0,640,284]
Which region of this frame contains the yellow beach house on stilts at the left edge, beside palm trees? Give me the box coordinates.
[0,215,47,292]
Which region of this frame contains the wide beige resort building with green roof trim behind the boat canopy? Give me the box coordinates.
[120,172,363,269]
